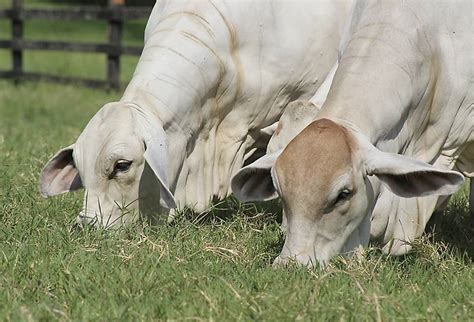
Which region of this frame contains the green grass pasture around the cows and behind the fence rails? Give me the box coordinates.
[0,2,474,321]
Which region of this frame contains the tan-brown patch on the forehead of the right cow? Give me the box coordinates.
[275,119,352,216]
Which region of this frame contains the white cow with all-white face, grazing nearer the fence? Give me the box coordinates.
[40,0,351,226]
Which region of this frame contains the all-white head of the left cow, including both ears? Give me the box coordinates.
[40,103,176,228]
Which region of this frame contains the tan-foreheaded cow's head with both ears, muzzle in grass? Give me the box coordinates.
[232,119,464,265]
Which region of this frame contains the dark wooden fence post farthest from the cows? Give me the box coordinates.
[11,0,23,82]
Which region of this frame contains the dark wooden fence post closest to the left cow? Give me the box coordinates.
[107,0,124,89]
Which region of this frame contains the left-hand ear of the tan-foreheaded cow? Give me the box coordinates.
[231,150,282,202]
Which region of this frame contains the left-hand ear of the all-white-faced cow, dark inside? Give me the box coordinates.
[39,145,83,198]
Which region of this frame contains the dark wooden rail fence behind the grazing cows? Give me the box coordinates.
[0,0,151,89]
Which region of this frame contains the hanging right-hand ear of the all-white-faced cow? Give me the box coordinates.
[145,135,176,209]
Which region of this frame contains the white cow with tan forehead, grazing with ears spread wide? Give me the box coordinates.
[232,1,474,265]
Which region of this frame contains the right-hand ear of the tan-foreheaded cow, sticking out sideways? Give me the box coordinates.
[366,147,464,198]
